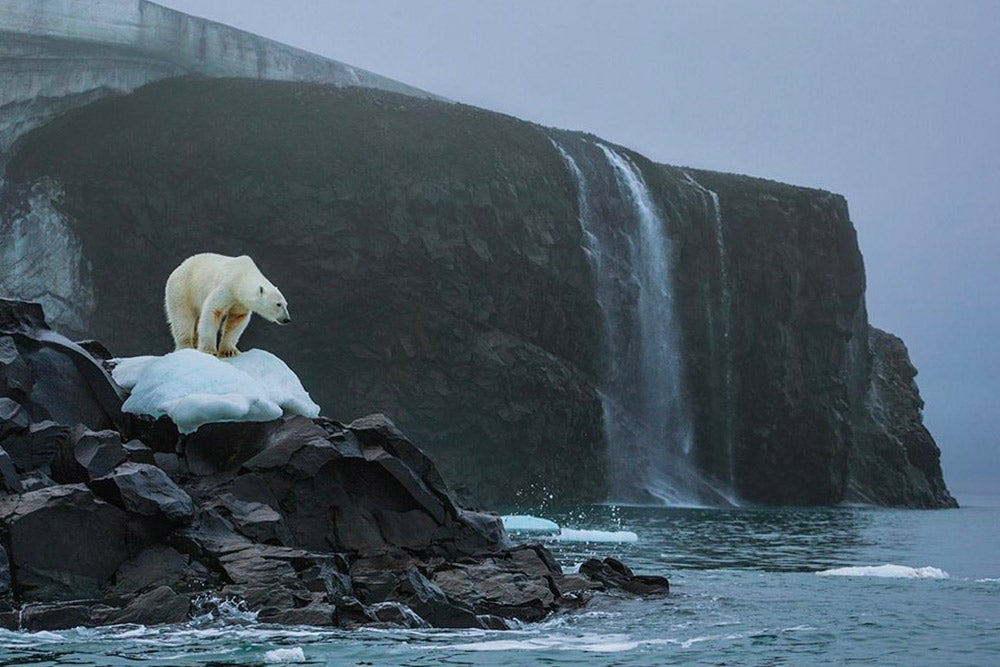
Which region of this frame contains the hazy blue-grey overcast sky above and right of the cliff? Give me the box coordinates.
[161,0,1000,492]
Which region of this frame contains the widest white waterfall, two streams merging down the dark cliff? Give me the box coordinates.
[552,139,730,505]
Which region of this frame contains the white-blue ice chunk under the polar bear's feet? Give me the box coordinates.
[112,350,319,433]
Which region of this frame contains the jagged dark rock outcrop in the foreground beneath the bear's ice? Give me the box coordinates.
[0,299,665,630]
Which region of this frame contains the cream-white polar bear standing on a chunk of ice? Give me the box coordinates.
[164,252,291,357]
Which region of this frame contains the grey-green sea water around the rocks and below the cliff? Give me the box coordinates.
[0,495,1000,665]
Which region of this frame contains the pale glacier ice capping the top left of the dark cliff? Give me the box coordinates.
[0,0,433,153]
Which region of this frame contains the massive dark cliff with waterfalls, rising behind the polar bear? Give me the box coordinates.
[4,73,953,505]
